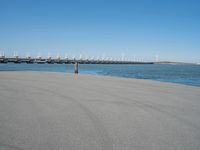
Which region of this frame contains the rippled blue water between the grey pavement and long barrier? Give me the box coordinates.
[0,64,200,86]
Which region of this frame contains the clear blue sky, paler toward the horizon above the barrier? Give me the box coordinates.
[0,0,200,62]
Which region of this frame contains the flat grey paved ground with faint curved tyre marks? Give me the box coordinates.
[0,72,200,150]
